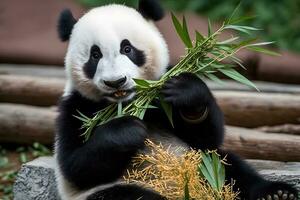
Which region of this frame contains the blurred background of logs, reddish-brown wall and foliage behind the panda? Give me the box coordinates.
[0,0,300,199]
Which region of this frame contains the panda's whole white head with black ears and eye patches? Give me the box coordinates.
[58,0,169,102]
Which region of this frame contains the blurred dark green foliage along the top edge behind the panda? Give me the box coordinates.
[78,0,300,52]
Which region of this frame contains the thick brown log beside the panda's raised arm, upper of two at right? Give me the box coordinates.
[213,91,300,128]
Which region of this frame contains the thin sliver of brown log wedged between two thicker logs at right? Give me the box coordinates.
[256,124,300,135]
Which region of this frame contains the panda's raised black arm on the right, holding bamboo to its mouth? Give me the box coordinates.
[162,73,224,150]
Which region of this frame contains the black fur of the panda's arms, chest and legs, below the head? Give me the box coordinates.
[57,73,297,200]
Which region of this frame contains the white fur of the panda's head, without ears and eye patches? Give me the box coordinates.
[65,5,169,100]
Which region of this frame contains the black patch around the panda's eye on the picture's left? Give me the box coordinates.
[83,45,103,79]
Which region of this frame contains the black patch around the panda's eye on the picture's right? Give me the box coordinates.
[120,39,146,67]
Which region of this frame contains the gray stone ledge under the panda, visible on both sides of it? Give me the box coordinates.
[14,157,300,200]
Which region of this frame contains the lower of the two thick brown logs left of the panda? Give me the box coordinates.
[0,104,57,144]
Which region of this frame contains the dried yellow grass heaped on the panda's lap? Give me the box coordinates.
[124,140,237,200]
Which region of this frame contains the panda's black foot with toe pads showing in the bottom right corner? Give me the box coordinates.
[249,181,298,200]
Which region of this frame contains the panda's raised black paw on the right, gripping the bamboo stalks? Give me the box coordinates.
[161,73,213,109]
